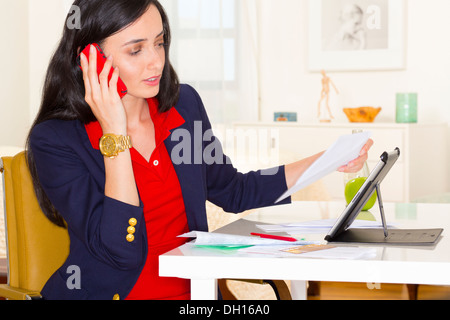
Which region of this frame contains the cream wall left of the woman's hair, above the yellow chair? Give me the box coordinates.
[0,0,67,148]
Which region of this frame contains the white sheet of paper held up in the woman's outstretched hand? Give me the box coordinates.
[275,132,371,203]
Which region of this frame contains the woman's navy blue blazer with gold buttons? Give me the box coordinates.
[30,85,290,300]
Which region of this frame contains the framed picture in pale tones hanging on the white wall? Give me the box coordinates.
[309,0,406,71]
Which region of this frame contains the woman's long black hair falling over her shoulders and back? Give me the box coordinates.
[27,0,180,227]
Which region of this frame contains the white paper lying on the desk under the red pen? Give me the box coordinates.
[178,231,317,247]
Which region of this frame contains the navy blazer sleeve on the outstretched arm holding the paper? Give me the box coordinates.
[187,86,291,213]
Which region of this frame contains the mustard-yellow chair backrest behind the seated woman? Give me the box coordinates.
[2,152,70,292]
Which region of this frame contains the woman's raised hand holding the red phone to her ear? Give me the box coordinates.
[80,45,127,135]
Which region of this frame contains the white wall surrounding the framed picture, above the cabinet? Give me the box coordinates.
[261,0,450,123]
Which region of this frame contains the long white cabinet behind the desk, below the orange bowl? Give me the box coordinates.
[230,123,450,202]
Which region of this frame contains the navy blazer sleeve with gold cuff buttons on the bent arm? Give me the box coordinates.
[30,123,147,270]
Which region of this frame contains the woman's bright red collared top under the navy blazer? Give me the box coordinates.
[86,99,190,300]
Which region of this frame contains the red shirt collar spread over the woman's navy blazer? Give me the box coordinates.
[85,98,186,150]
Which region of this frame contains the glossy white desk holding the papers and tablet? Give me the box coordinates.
[160,202,450,300]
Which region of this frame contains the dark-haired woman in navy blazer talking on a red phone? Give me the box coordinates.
[28,0,370,300]
